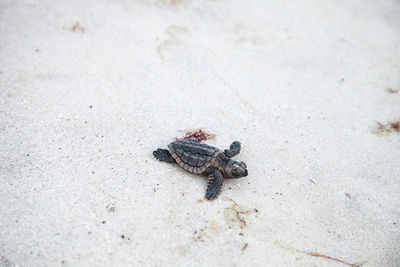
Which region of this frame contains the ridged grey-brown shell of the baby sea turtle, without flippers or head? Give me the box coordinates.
[168,139,220,174]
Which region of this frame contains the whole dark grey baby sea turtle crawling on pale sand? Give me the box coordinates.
[153,139,248,200]
